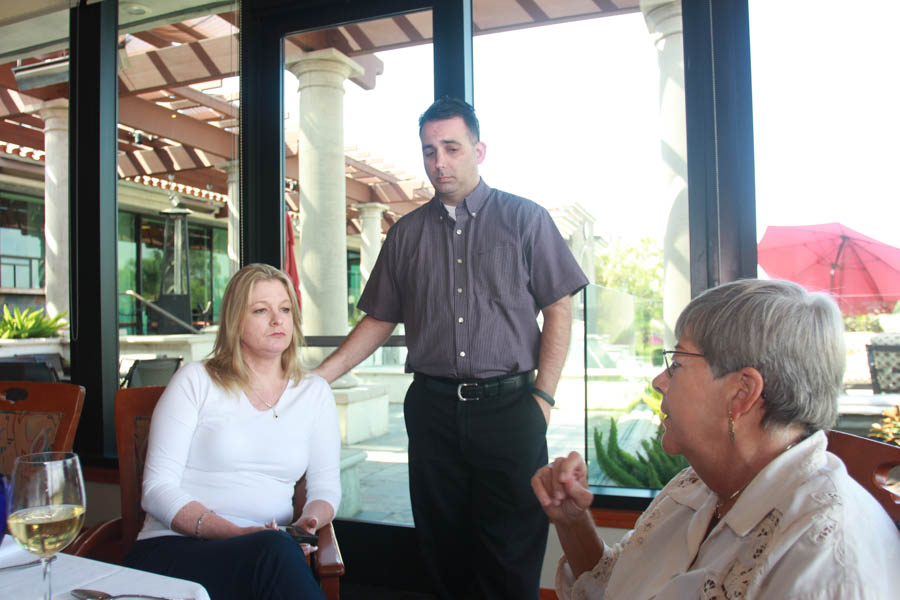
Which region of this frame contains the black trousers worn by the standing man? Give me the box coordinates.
[404,372,549,600]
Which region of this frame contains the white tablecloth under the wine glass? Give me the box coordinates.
[0,535,209,600]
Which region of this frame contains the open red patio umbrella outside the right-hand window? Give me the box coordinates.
[757,223,900,315]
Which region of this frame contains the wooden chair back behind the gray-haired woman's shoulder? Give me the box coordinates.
[828,431,900,523]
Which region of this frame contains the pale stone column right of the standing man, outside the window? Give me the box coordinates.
[641,0,691,348]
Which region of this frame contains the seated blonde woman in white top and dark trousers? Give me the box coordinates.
[126,264,341,600]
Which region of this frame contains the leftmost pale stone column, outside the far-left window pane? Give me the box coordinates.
[38,98,69,324]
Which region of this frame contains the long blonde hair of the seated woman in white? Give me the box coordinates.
[206,263,303,392]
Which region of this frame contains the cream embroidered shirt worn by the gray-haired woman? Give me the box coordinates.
[556,432,900,600]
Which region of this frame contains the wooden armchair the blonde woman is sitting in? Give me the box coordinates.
[64,386,344,600]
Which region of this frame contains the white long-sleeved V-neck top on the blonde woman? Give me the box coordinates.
[138,362,341,539]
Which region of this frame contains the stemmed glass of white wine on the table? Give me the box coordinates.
[7,452,85,600]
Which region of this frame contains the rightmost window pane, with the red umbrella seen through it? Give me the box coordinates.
[749,0,900,435]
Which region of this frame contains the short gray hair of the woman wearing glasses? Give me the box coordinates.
[675,279,846,432]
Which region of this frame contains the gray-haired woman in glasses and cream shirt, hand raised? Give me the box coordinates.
[532,280,900,600]
